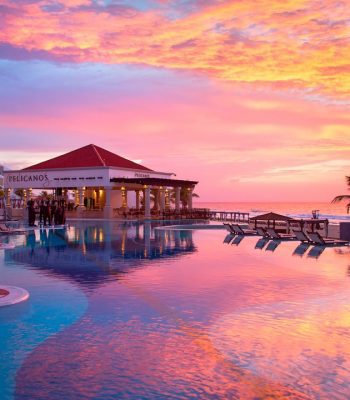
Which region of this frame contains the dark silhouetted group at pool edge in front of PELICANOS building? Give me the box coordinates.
[27,199,66,226]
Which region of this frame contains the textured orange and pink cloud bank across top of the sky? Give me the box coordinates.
[0,0,350,101]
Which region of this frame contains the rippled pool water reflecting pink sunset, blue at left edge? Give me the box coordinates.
[0,222,350,400]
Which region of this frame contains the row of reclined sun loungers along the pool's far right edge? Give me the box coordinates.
[224,223,349,246]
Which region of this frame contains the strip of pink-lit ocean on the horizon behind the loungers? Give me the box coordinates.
[193,201,350,222]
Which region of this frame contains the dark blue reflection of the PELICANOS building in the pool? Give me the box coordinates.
[5,222,196,286]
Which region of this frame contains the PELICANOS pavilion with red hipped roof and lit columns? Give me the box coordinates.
[4,144,198,218]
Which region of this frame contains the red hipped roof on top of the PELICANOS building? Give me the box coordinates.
[24,144,152,171]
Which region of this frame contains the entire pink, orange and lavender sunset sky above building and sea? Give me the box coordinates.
[0,0,350,202]
